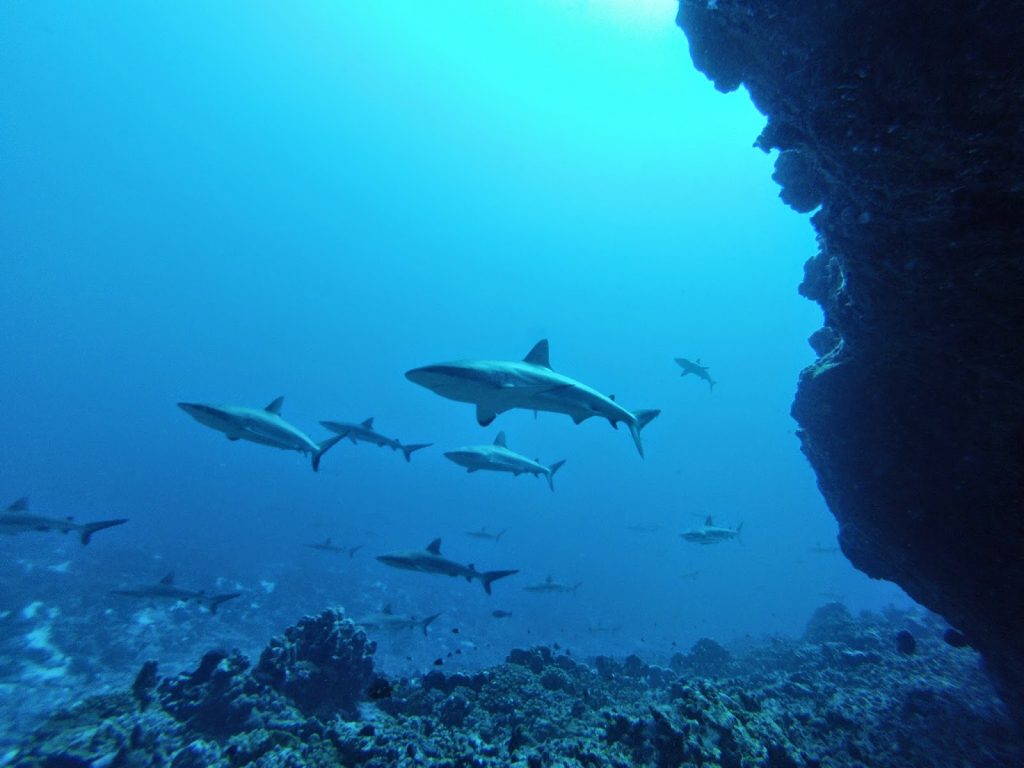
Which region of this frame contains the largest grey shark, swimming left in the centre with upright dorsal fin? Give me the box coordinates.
[406,339,662,458]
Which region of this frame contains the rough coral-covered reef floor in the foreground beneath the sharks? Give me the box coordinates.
[9,603,1024,768]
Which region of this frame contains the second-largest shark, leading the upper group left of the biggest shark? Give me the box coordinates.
[178,397,341,472]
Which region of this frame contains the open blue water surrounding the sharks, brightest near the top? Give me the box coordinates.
[0,0,906,708]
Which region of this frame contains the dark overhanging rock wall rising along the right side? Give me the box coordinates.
[679,0,1024,722]
